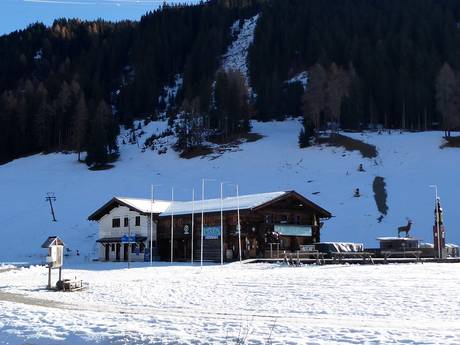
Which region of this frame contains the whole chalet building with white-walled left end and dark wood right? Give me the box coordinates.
[88,191,331,261]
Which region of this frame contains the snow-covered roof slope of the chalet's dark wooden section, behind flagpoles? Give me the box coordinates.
[160,192,288,216]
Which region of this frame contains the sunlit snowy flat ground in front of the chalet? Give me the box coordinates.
[0,263,460,345]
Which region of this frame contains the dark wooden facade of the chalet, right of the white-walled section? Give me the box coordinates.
[158,192,331,261]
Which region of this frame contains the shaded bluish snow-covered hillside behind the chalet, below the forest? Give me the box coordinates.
[0,119,460,262]
